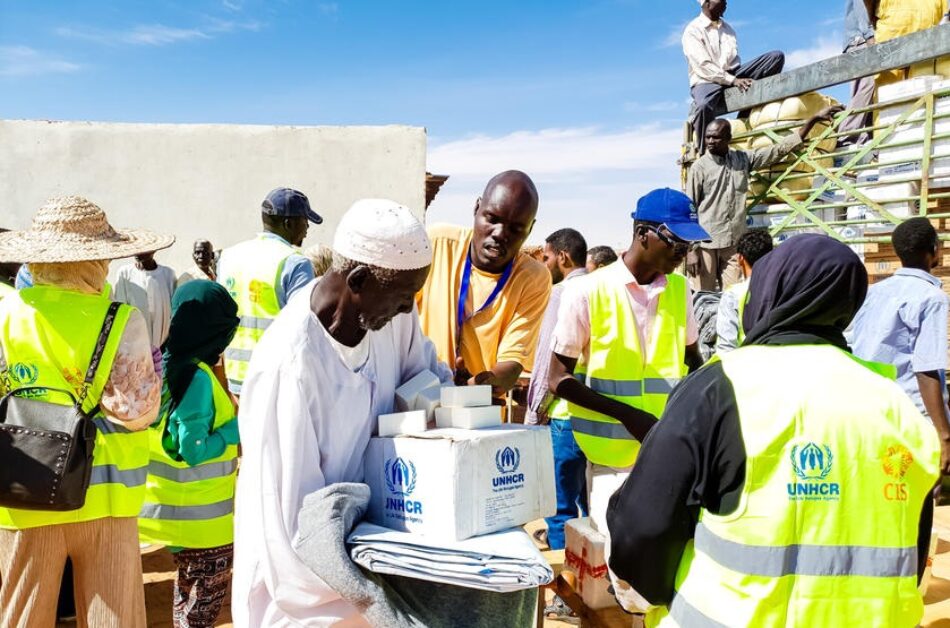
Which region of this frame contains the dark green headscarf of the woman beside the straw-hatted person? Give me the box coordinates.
[162,279,239,410]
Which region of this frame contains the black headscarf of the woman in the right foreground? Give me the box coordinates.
[742,234,868,351]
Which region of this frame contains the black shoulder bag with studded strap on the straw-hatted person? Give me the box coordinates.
[0,303,119,511]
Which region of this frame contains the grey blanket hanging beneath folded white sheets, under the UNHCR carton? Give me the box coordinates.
[295,483,538,628]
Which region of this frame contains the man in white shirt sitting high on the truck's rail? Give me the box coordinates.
[683,0,785,154]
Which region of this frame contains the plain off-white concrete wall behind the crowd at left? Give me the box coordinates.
[0,121,426,272]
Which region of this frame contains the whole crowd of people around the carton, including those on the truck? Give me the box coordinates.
[0,0,950,627]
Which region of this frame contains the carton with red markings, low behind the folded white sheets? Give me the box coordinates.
[564,517,617,610]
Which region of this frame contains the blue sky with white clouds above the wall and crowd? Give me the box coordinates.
[0,0,844,246]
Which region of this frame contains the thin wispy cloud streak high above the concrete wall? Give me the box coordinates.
[56,19,262,46]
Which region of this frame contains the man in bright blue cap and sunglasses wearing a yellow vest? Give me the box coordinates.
[548,188,709,608]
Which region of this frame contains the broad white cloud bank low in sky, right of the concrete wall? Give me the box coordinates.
[428,125,682,247]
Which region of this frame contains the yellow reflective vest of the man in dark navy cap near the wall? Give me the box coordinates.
[218,235,297,393]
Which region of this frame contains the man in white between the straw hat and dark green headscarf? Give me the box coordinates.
[113,252,176,347]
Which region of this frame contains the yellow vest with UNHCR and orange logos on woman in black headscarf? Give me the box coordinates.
[647,346,940,626]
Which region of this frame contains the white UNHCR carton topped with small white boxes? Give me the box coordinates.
[363,371,557,541]
